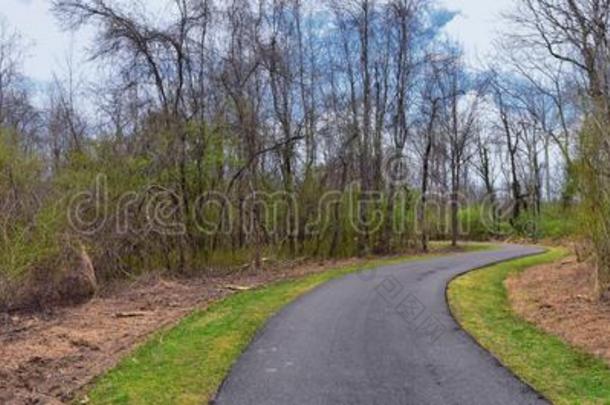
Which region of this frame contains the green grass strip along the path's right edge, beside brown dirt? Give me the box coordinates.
[448,249,610,404]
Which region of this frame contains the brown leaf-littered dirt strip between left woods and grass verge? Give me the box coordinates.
[0,260,356,404]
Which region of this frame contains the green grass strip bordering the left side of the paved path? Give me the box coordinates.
[88,244,492,405]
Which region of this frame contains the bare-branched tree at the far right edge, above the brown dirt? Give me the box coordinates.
[509,0,610,295]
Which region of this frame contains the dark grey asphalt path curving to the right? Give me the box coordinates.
[215,245,545,405]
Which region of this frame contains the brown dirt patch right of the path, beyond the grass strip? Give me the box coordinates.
[506,257,610,364]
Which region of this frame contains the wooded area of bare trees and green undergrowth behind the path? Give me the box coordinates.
[0,0,610,308]
